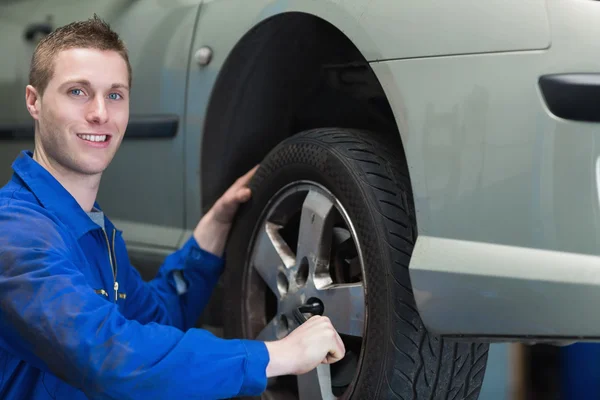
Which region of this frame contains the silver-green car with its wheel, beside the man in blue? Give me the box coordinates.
[0,0,600,400]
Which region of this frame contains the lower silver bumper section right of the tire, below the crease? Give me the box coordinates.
[411,236,600,342]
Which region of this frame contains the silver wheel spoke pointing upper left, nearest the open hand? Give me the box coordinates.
[253,223,295,297]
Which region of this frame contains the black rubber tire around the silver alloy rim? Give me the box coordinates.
[223,129,489,400]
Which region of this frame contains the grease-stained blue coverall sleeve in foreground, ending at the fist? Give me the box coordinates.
[0,209,269,399]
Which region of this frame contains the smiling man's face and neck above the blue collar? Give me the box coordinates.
[25,46,131,210]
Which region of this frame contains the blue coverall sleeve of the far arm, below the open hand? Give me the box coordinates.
[124,236,223,331]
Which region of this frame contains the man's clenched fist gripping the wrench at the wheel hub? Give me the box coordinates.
[266,315,346,378]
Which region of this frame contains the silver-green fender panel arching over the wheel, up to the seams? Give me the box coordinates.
[186,0,550,235]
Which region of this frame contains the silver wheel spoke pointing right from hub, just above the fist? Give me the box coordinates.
[318,283,365,337]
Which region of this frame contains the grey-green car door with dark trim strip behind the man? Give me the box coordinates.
[2,0,201,266]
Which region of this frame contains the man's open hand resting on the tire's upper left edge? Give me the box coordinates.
[194,165,259,257]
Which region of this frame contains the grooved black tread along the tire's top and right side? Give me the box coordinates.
[220,128,489,400]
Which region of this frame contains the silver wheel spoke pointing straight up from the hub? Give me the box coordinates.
[297,191,334,266]
